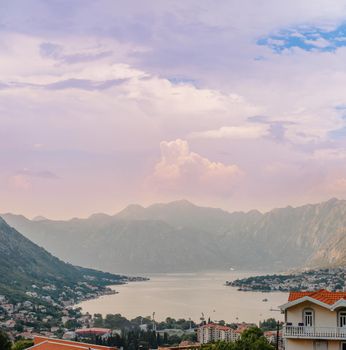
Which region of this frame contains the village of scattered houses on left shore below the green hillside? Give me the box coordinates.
[0,276,147,339]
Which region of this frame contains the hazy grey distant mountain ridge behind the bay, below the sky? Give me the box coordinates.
[3,199,346,273]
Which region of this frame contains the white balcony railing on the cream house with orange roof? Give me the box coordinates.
[283,326,346,340]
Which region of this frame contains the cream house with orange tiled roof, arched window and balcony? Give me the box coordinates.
[280,289,346,350]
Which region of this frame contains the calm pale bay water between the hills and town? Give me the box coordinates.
[78,271,288,323]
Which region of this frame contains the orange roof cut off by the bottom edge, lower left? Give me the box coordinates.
[27,336,117,350]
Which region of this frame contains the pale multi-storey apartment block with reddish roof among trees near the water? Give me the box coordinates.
[197,323,240,344]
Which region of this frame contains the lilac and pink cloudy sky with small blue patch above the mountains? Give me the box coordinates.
[0,0,346,218]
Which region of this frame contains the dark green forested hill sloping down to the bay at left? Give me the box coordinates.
[0,218,127,300]
